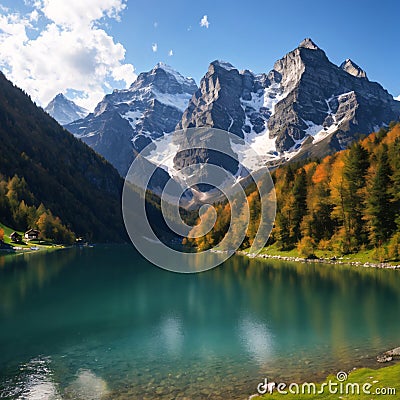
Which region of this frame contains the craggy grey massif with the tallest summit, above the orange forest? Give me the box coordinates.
[180,39,400,165]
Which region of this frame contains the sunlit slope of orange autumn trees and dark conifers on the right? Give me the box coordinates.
[192,123,400,260]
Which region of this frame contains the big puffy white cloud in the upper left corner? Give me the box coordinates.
[0,0,136,110]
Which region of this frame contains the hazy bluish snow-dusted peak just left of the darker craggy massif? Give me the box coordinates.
[66,63,197,176]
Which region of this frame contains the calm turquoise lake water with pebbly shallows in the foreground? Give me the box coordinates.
[0,246,400,400]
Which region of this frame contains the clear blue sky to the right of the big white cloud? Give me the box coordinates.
[117,0,400,89]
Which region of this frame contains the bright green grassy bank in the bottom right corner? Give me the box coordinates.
[252,363,400,400]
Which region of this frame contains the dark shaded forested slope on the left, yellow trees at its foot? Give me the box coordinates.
[0,73,126,241]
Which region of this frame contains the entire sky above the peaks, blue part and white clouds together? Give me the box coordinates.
[0,0,400,108]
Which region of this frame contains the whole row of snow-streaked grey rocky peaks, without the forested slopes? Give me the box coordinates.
[65,39,400,176]
